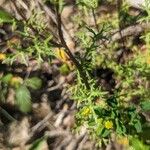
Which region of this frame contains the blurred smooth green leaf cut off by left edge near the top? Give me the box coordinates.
[0,9,14,23]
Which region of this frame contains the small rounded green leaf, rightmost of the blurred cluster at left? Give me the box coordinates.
[25,77,42,90]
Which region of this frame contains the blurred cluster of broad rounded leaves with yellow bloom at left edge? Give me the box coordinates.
[0,74,42,113]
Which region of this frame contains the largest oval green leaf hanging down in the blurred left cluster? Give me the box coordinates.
[16,85,31,113]
